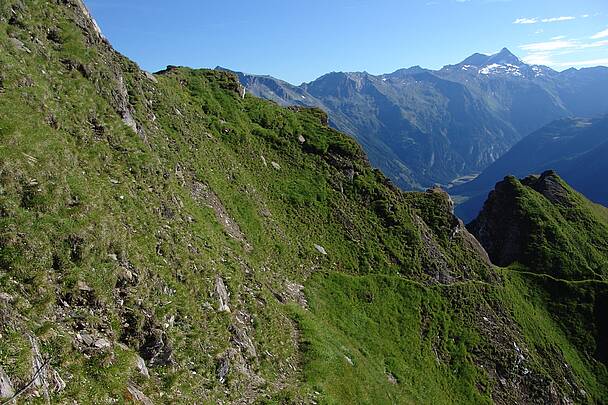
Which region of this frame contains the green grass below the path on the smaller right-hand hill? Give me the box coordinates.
[500,268,608,403]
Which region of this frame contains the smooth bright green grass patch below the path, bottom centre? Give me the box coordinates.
[296,273,491,404]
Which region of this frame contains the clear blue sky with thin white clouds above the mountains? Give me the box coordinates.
[85,0,608,84]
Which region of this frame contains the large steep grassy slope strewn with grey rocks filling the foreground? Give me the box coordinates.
[0,0,607,403]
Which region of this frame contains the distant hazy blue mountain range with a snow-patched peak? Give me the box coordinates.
[227,48,608,189]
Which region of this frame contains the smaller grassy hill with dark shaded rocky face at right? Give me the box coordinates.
[468,171,608,400]
